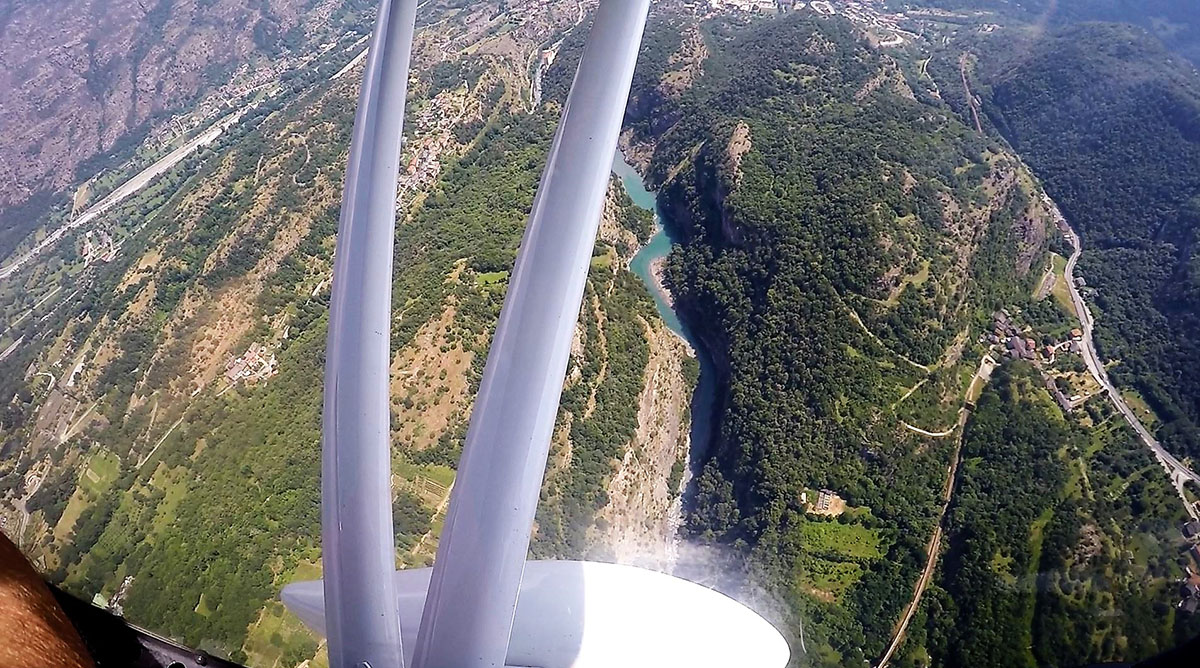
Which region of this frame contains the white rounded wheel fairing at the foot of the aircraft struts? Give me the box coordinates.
[283,561,790,668]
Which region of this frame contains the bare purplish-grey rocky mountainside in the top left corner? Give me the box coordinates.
[0,0,356,211]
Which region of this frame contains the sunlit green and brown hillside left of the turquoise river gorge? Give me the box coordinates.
[0,4,690,666]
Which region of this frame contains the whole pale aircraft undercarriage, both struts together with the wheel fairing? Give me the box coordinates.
[296,0,788,668]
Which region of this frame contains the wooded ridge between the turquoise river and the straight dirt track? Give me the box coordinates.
[609,14,1070,666]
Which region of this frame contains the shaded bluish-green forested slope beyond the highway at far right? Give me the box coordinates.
[976,25,1200,456]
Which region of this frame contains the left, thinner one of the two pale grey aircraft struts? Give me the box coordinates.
[320,0,416,668]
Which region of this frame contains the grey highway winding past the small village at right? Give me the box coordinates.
[1060,198,1200,519]
